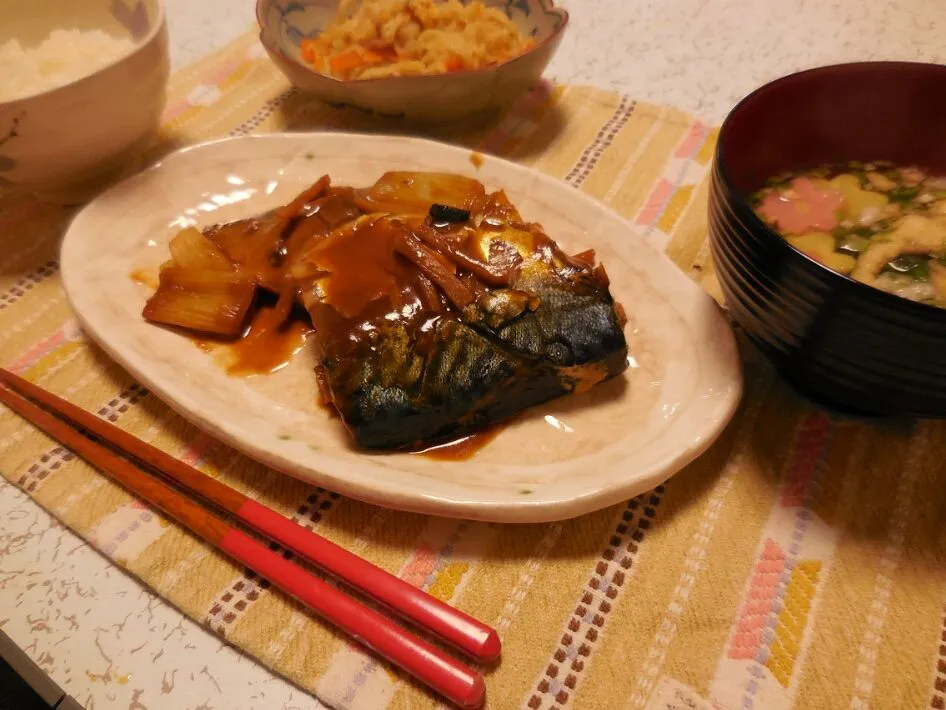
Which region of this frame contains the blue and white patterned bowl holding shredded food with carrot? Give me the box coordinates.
[256,0,568,123]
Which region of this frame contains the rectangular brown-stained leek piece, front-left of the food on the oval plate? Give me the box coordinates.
[142,267,256,337]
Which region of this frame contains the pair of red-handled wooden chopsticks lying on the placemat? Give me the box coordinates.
[0,368,500,708]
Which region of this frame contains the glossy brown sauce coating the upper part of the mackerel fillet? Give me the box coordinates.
[292,191,555,355]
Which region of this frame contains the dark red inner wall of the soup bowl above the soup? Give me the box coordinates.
[720,62,946,194]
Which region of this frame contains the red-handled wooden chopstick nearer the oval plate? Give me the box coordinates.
[0,368,501,663]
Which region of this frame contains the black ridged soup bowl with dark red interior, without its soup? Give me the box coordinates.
[709,62,946,417]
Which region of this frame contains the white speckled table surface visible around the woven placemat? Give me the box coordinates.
[0,0,946,710]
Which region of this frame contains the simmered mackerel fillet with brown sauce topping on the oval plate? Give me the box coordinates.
[145,173,627,450]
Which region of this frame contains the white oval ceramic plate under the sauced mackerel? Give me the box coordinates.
[61,133,742,522]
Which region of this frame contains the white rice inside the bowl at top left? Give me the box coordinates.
[0,30,135,101]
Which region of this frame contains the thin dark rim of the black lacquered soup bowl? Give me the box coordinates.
[711,60,946,320]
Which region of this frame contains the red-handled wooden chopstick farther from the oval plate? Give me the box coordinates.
[0,382,486,708]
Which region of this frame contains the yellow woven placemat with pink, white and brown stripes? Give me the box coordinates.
[0,27,946,710]
